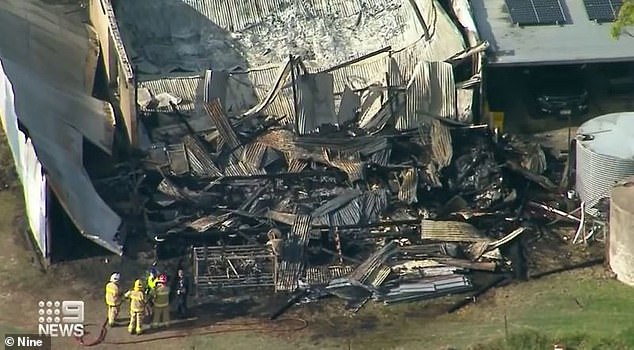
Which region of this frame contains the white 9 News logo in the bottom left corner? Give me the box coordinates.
[37,300,84,337]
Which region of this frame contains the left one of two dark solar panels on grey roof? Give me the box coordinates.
[505,0,566,25]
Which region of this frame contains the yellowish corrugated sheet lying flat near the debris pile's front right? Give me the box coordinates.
[421,220,491,242]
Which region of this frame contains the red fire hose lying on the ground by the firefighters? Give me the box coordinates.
[76,318,308,346]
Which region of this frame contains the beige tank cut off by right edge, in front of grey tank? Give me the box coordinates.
[608,177,634,286]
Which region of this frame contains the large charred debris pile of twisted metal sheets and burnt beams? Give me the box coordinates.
[99,94,572,308]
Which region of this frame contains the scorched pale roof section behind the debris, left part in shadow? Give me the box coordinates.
[115,0,464,74]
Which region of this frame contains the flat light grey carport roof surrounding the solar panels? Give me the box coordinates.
[471,0,634,66]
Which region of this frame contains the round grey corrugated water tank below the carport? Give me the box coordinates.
[576,112,634,213]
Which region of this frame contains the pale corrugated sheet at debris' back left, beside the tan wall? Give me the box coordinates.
[138,75,204,113]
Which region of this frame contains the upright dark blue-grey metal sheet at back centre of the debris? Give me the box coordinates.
[296,73,337,135]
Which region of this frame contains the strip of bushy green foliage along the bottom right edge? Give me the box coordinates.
[470,328,634,350]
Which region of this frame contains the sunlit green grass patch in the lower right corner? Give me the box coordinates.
[324,267,634,349]
